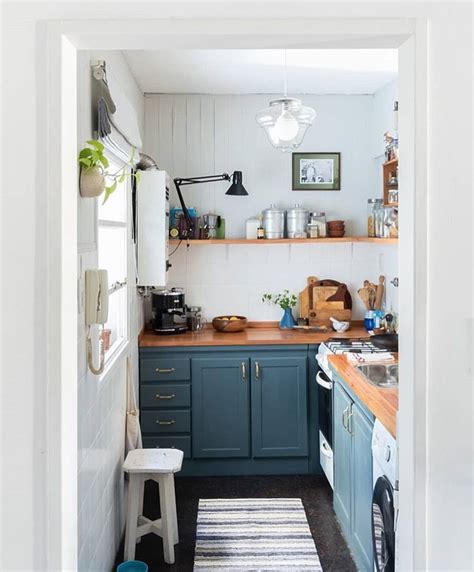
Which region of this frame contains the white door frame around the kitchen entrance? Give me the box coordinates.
[44,13,427,570]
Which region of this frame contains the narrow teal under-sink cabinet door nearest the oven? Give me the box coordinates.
[333,383,352,537]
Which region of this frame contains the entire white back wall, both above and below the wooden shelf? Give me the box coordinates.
[145,93,398,320]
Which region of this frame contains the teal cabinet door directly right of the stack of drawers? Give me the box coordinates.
[191,356,250,458]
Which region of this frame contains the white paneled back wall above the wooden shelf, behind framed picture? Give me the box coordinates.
[145,95,381,237]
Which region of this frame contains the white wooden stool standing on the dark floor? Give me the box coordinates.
[123,449,183,564]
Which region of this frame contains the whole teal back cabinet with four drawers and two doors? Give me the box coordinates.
[140,344,320,476]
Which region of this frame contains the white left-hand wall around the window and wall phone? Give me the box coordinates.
[77,51,144,572]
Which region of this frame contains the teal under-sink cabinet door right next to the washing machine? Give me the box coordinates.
[349,404,373,570]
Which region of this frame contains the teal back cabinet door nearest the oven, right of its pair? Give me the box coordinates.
[251,356,308,457]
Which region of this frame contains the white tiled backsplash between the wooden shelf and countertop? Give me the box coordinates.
[169,242,398,320]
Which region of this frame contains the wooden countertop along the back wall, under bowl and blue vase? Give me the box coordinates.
[138,322,368,348]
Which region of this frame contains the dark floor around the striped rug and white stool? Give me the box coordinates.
[120,475,356,572]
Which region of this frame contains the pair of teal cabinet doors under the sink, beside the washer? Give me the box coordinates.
[333,382,373,572]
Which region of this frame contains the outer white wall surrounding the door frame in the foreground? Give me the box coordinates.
[0,4,473,570]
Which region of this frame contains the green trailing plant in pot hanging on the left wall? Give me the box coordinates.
[78,139,140,204]
